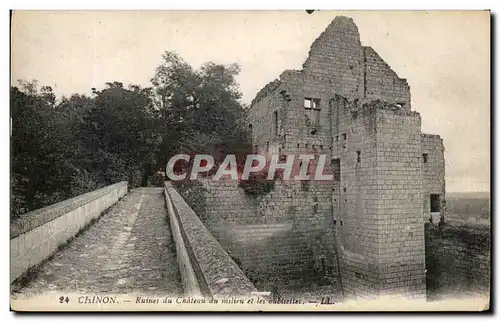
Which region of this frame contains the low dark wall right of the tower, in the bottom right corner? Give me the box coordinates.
[425,223,491,300]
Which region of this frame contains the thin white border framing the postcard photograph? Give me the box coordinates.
[0,0,500,320]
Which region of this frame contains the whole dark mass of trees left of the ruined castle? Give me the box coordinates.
[10,52,249,216]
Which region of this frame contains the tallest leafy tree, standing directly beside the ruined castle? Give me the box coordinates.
[152,52,248,168]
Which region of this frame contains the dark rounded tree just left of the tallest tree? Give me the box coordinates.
[79,82,159,186]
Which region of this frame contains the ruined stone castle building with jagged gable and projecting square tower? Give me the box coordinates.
[247,17,445,299]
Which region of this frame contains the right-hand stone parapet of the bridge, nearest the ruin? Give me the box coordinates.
[165,182,257,298]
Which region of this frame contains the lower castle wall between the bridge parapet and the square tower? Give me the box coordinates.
[188,180,339,290]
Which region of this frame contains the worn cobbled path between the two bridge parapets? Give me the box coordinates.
[13,188,182,296]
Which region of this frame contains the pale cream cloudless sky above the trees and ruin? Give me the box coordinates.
[11,11,490,192]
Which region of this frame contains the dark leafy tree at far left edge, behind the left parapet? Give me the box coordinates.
[11,81,76,215]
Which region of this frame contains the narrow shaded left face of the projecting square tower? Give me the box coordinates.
[332,96,378,298]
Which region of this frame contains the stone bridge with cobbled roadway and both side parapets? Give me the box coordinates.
[10,182,256,298]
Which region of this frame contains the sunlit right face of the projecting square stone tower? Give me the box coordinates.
[376,109,425,299]
